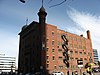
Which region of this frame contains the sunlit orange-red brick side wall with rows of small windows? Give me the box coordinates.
[46,24,93,73]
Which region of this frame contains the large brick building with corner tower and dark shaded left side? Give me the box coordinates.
[18,6,94,75]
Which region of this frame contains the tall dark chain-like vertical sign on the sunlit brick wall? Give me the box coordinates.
[61,35,69,68]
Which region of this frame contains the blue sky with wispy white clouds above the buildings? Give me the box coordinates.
[0,0,100,67]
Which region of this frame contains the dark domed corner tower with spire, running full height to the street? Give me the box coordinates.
[38,0,47,75]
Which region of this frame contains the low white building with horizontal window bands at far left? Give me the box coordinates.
[0,54,16,73]
